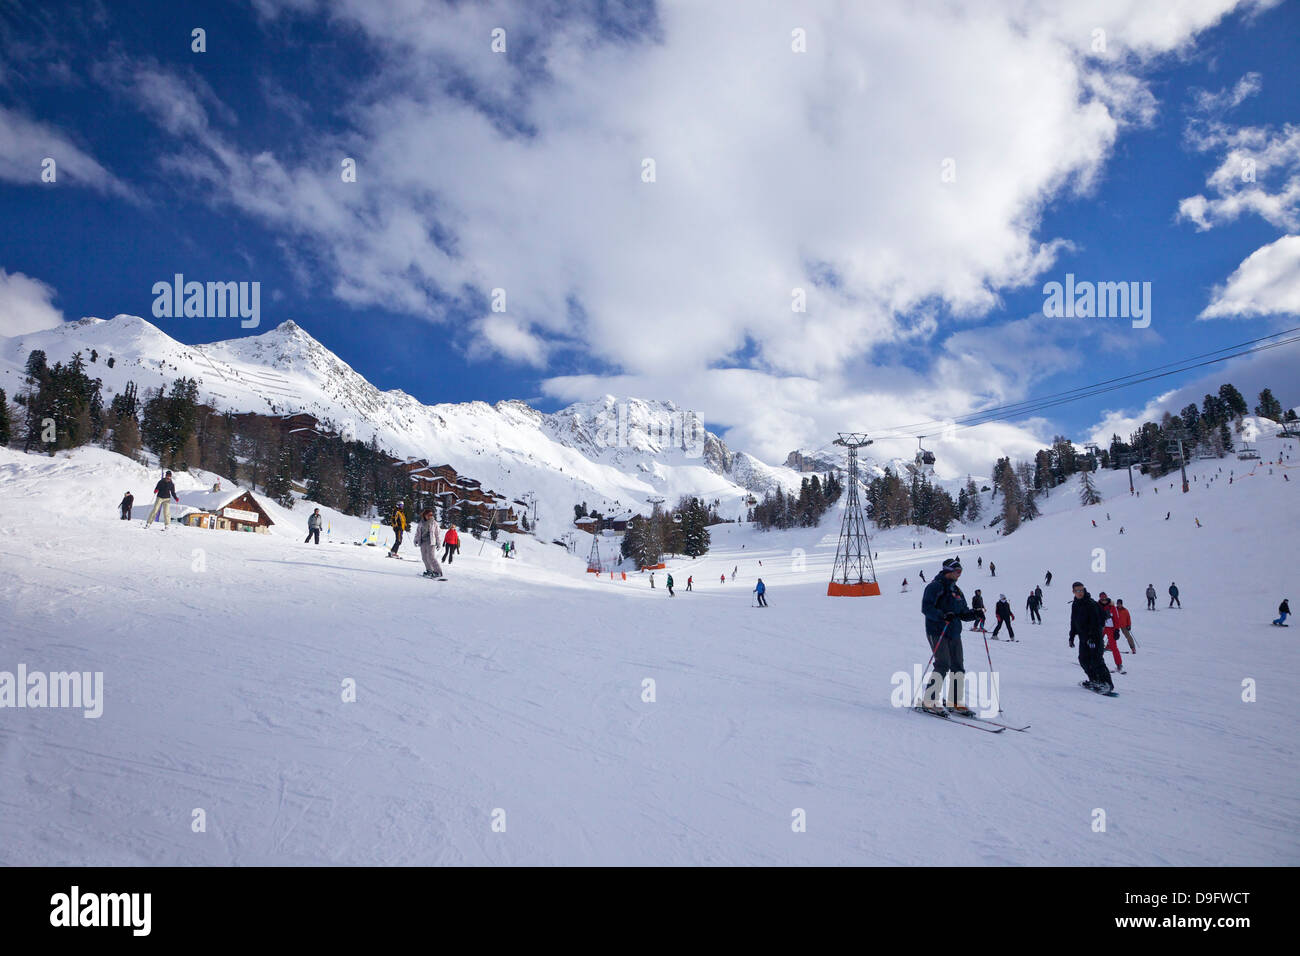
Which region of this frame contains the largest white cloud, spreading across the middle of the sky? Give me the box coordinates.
[131,0,1268,467]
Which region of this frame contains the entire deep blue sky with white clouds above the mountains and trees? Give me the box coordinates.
[0,0,1300,470]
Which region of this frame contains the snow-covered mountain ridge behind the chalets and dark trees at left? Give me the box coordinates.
[0,315,798,535]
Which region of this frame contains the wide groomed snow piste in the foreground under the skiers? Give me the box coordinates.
[0,437,1300,868]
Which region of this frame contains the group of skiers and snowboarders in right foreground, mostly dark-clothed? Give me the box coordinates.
[920,558,1154,715]
